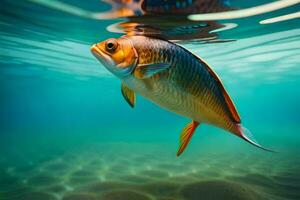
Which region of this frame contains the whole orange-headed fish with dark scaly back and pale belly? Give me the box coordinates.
[91,35,272,156]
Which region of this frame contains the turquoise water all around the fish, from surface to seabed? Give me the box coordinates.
[0,0,300,200]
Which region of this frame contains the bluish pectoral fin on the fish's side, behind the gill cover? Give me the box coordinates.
[134,63,170,79]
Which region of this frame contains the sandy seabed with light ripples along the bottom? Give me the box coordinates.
[0,143,300,200]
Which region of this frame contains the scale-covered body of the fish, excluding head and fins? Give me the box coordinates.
[123,36,234,133]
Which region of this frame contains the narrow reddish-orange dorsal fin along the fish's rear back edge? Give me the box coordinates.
[199,55,241,123]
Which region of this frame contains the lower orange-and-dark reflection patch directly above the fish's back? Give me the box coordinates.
[115,16,227,42]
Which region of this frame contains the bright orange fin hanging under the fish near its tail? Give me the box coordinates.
[177,120,199,156]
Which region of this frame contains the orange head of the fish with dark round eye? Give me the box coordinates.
[91,37,138,79]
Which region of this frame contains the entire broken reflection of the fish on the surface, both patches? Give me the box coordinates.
[102,0,236,42]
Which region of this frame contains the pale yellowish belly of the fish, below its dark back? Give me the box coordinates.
[126,76,228,130]
